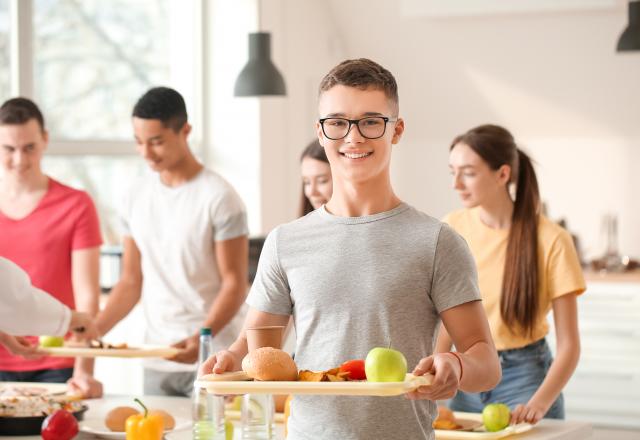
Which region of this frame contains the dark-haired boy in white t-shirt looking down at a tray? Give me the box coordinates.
[97,87,248,395]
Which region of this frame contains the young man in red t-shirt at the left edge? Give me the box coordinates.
[0,98,102,397]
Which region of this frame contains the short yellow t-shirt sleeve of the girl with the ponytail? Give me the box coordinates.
[546,229,586,300]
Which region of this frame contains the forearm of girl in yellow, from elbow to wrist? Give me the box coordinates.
[523,340,580,409]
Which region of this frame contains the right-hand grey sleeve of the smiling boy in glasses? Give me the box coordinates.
[431,224,480,313]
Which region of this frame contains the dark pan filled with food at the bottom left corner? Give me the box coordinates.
[0,382,88,435]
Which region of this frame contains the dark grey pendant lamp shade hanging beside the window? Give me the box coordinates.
[233,32,287,96]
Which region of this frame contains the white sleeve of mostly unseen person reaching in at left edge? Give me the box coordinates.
[0,257,71,336]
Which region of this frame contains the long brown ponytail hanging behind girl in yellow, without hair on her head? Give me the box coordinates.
[500,149,540,335]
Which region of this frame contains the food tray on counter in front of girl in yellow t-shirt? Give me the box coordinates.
[433,405,533,440]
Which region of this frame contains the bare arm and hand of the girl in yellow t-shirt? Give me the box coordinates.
[511,293,580,423]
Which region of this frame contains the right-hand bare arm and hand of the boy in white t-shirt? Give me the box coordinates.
[170,235,249,363]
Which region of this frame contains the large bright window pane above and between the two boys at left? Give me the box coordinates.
[33,0,171,140]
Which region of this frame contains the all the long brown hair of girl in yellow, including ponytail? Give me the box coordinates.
[450,125,540,335]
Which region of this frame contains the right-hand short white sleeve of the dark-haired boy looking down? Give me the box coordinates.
[211,188,249,241]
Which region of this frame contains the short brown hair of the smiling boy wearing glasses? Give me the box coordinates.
[318,58,400,113]
